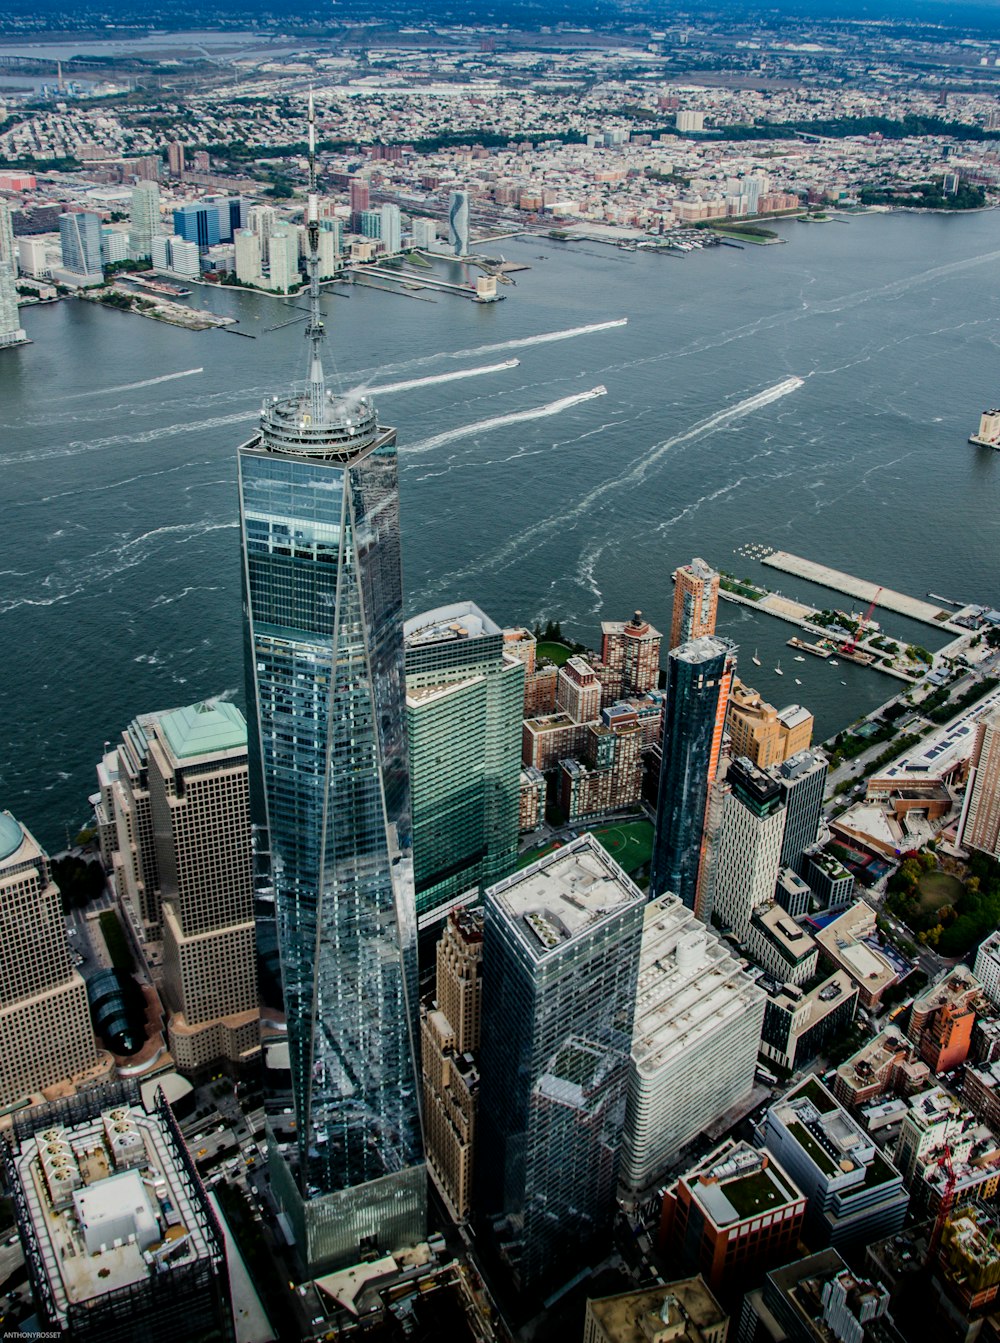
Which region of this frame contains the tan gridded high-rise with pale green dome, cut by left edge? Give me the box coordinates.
[0,811,98,1107]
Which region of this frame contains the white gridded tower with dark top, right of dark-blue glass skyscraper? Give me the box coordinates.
[713,756,785,941]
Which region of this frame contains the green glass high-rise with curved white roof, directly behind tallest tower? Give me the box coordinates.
[405,602,525,927]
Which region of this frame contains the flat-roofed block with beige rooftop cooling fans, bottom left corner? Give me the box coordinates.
[3,1082,236,1343]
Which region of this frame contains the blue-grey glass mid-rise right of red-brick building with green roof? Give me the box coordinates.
[762,1077,910,1249]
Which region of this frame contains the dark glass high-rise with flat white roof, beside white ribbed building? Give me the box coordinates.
[474,835,644,1291]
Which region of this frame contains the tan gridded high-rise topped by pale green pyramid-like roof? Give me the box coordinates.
[149,701,258,1072]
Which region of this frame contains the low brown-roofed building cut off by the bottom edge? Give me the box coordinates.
[584,1273,729,1343]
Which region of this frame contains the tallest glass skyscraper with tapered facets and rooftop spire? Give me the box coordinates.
[239,99,426,1270]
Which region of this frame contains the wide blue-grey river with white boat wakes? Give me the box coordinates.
[0,212,1000,846]
